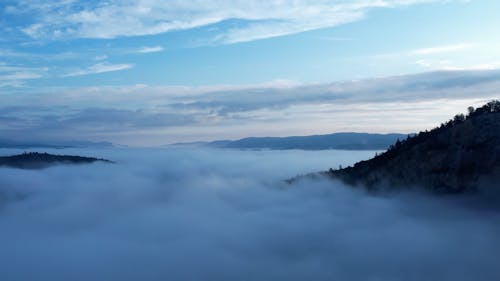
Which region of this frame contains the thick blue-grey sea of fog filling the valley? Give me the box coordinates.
[0,148,500,281]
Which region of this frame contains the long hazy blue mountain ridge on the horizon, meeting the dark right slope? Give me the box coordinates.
[173,133,408,150]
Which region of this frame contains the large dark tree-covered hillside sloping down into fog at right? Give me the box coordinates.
[318,101,500,193]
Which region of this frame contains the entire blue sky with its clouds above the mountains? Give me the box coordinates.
[0,0,500,146]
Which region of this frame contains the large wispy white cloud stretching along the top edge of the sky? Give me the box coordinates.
[7,0,458,43]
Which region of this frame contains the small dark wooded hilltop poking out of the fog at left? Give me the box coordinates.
[0,152,112,169]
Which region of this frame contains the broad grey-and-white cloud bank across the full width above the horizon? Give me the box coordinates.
[0,70,500,145]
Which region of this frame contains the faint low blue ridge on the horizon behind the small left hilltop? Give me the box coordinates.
[0,139,114,148]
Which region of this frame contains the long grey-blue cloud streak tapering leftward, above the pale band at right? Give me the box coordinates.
[166,71,500,113]
